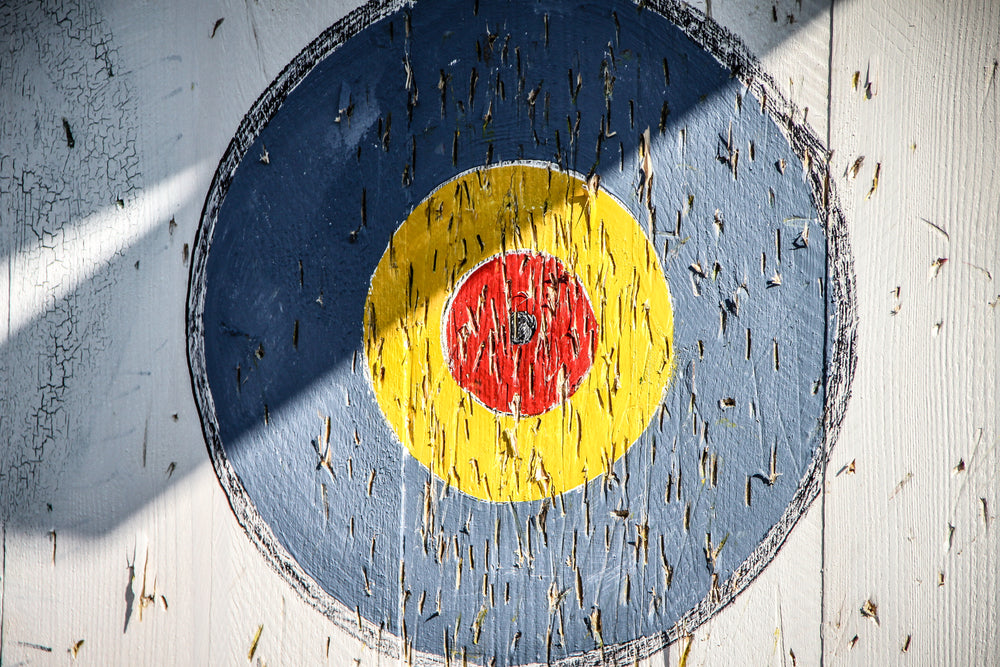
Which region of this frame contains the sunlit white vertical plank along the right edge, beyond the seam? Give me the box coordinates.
[823,2,1000,665]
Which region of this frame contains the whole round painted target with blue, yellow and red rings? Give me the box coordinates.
[188,0,853,665]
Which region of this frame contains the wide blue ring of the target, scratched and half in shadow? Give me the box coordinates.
[195,0,828,665]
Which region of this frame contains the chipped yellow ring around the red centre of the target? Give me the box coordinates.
[364,163,674,502]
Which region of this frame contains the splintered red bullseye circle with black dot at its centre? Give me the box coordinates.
[443,253,598,415]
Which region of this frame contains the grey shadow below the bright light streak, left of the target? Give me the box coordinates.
[0,221,209,535]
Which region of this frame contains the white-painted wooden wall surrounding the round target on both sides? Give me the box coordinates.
[0,0,1000,665]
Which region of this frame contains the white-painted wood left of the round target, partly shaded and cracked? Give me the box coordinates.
[0,0,377,665]
